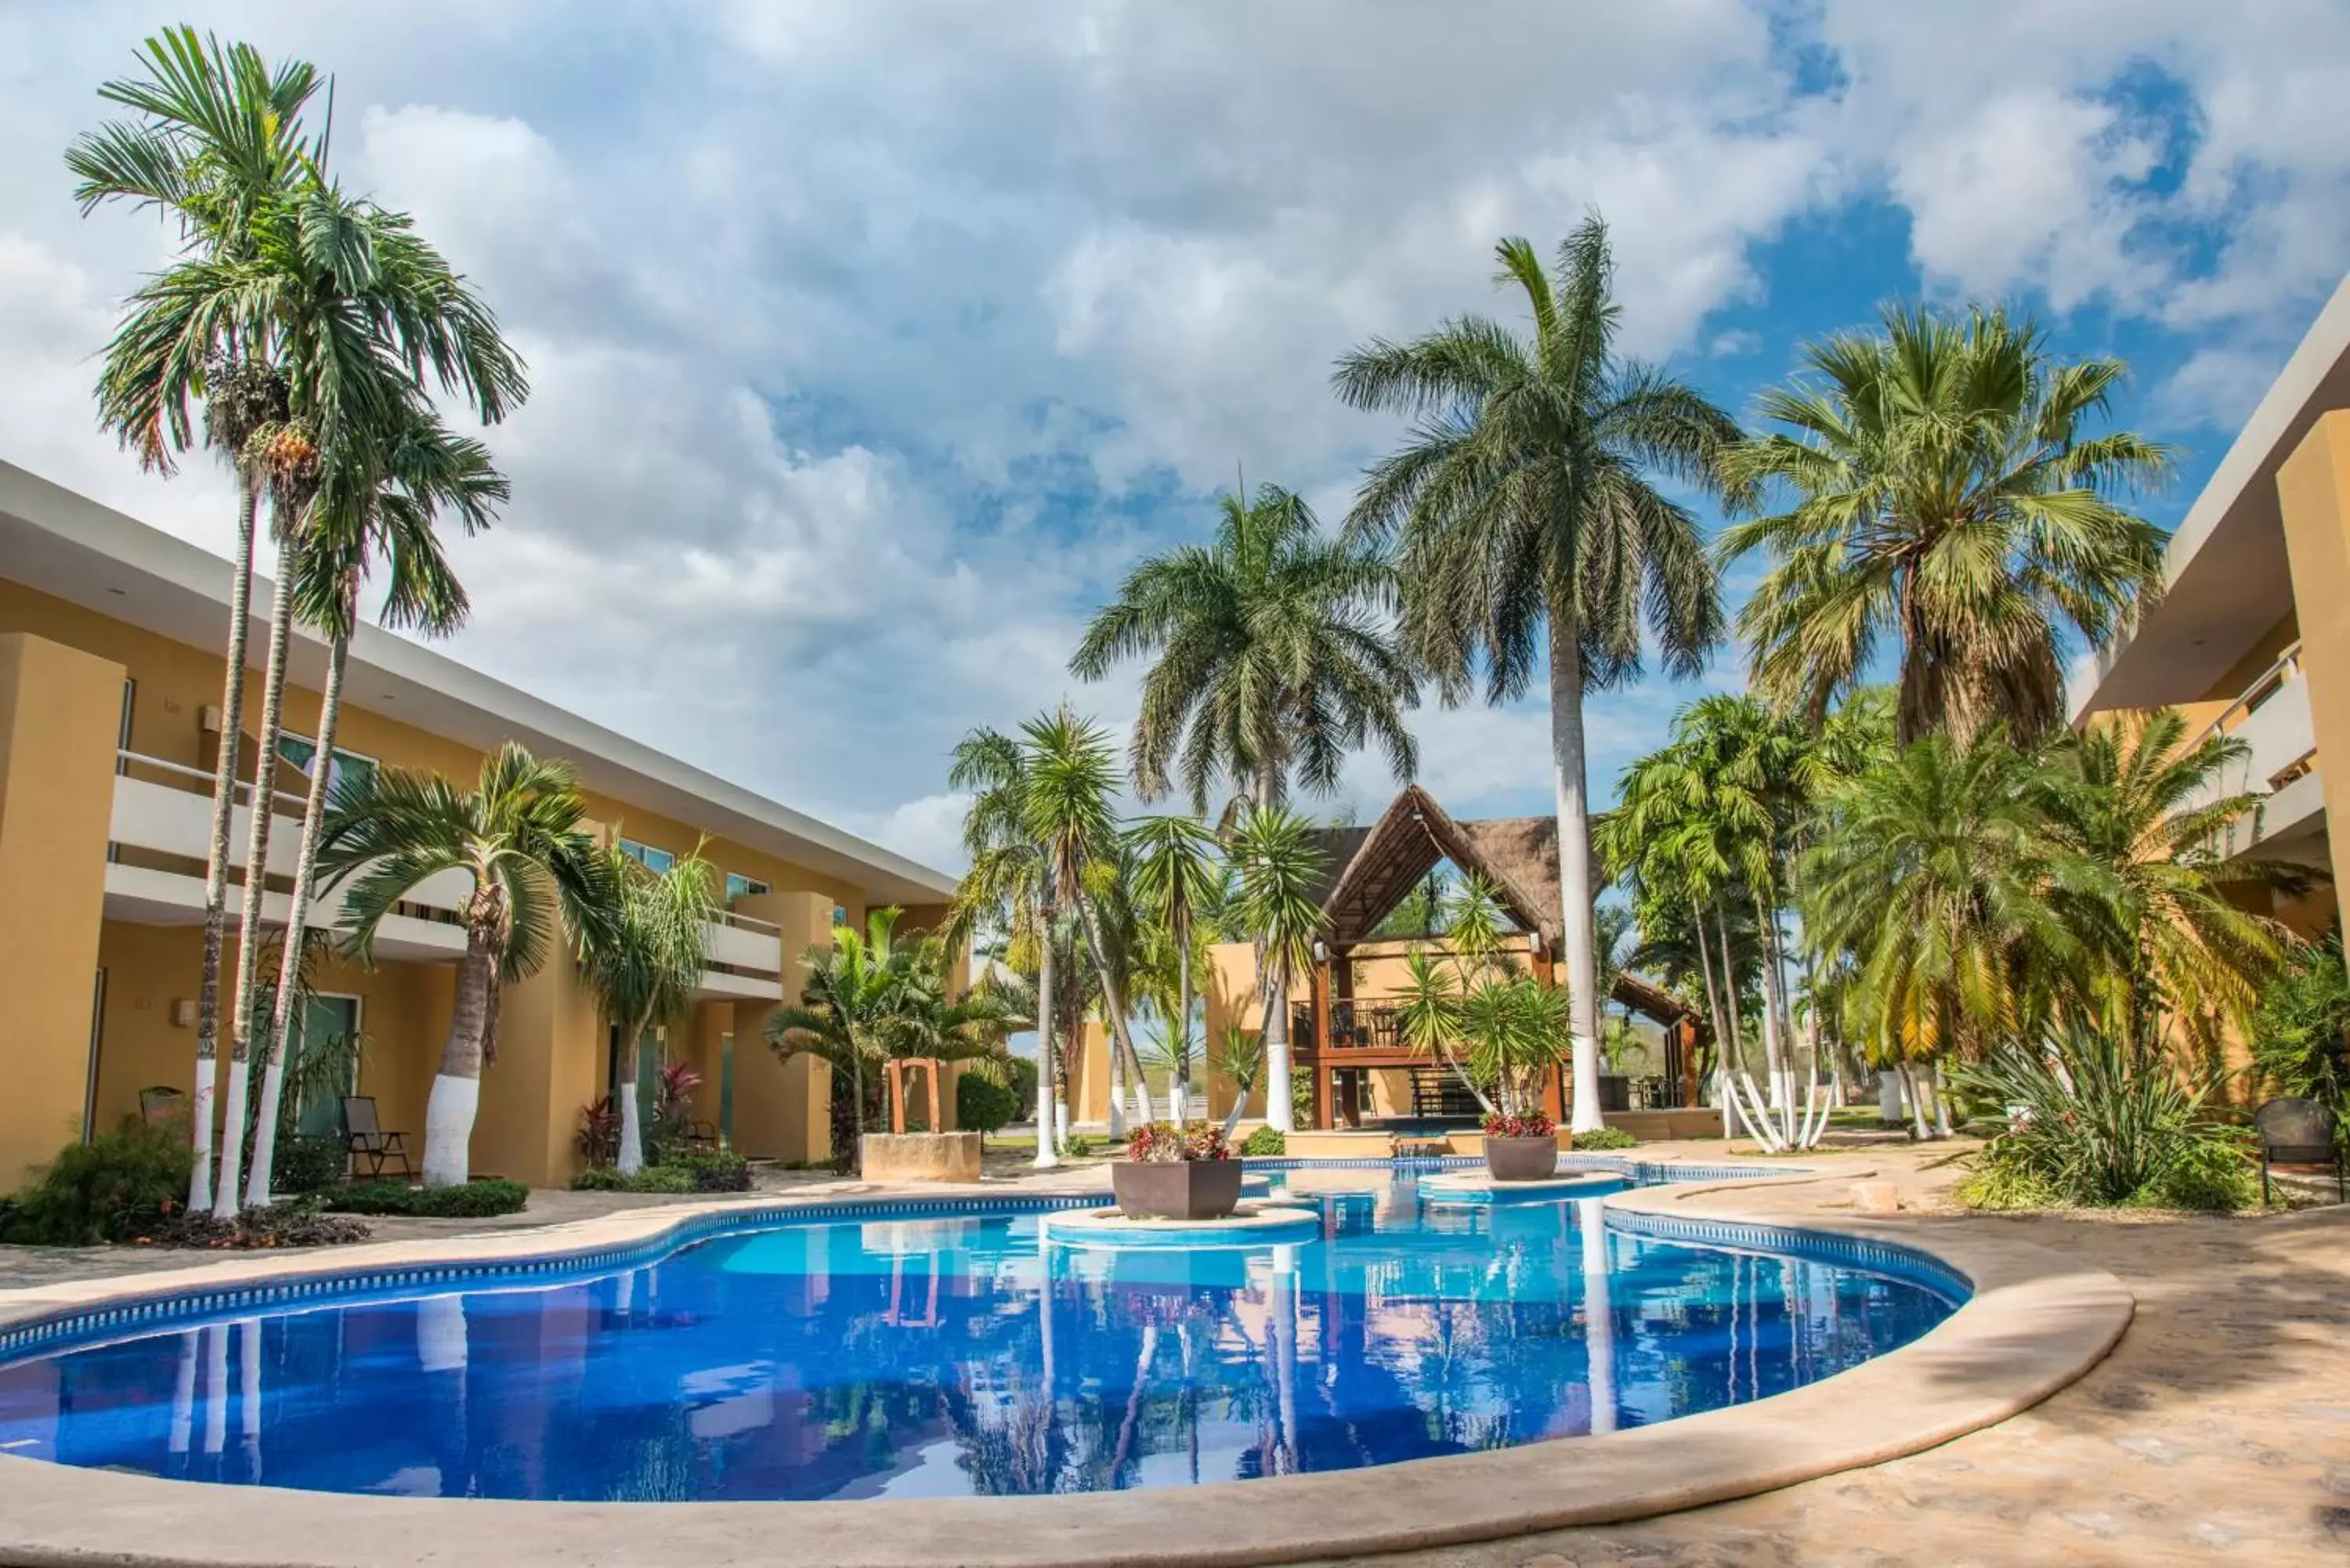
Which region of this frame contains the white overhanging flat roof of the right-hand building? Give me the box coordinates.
[2075,277,2350,714]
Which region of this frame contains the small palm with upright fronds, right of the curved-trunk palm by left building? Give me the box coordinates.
[578,840,719,1176]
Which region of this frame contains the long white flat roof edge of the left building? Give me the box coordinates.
[0,461,954,905]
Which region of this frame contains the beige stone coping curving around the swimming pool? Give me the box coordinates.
[0,1162,2134,1568]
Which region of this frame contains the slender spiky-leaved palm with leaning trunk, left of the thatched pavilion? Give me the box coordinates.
[1020,707,1152,1133]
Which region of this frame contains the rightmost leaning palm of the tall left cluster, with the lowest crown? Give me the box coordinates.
[244,409,508,1204]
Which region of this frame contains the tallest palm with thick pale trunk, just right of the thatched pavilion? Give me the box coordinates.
[1332,219,1739,1133]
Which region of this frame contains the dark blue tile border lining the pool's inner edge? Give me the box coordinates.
[0,1154,1908,1364]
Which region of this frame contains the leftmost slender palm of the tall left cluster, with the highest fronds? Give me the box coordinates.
[66,28,317,1209]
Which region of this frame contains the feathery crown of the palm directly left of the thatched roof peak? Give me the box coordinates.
[1069,484,1419,814]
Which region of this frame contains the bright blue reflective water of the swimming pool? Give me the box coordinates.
[0,1171,1953,1500]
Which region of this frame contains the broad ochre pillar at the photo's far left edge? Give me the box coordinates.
[0,632,126,1190]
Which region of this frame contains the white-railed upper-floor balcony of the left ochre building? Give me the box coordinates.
[106,752,783,1002]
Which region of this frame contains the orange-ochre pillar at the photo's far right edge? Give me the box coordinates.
[2277,409,2350,907]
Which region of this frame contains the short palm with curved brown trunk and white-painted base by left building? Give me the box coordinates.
[317,740,618,1187]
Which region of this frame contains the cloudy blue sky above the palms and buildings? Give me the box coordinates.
[0,0,2350,870]
